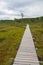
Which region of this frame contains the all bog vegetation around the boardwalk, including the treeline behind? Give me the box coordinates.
[0,17,43,65]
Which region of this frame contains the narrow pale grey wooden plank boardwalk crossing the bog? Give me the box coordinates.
[13,24,40,65]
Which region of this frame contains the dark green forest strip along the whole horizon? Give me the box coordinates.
[0,17,43,24]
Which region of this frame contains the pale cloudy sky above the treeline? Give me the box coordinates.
[0,0,43,20]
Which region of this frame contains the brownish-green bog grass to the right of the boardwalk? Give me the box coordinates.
[30,22,43,65]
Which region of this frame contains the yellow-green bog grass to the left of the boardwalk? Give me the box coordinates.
[0,24,25,65]
